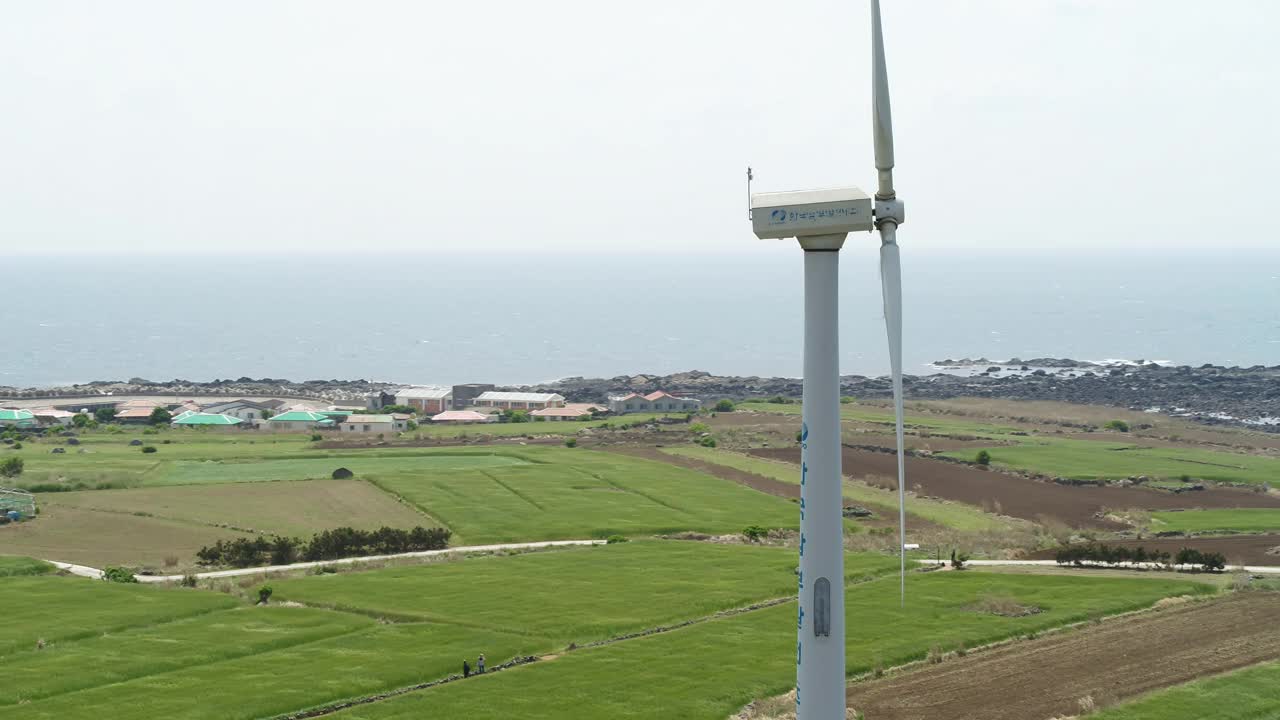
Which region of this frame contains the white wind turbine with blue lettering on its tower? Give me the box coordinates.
[749,0,906,720]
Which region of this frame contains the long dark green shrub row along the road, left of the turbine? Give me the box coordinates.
[196,525,452,568]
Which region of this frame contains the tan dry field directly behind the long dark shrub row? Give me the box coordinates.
[40,480,434,537]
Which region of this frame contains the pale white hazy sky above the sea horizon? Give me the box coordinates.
[0,0,1280,256]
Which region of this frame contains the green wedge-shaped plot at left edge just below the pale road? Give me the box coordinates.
[0,577,237,657]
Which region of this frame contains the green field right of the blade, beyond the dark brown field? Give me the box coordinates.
[942,438,1280,484]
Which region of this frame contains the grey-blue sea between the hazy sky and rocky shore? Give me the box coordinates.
[0,251,1280,387]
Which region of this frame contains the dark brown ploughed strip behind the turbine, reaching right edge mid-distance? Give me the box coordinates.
[750,447,1280,529]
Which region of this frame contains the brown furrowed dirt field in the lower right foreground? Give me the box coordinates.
[847,592,1280,720]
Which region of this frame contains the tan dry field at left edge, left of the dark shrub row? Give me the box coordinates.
[0,504,248,571]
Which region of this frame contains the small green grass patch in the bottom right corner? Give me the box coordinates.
[1091,662,1280,720]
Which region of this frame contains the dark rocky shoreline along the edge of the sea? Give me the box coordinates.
[0,357,1280,432]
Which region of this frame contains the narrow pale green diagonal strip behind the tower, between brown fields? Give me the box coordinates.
[663,447,1007,530]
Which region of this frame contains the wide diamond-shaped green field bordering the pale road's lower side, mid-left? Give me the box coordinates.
[274,541,896,643]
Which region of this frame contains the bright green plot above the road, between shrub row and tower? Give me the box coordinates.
[376,447,799,544]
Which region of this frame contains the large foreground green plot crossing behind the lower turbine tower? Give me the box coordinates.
[334,573,1206,720]
